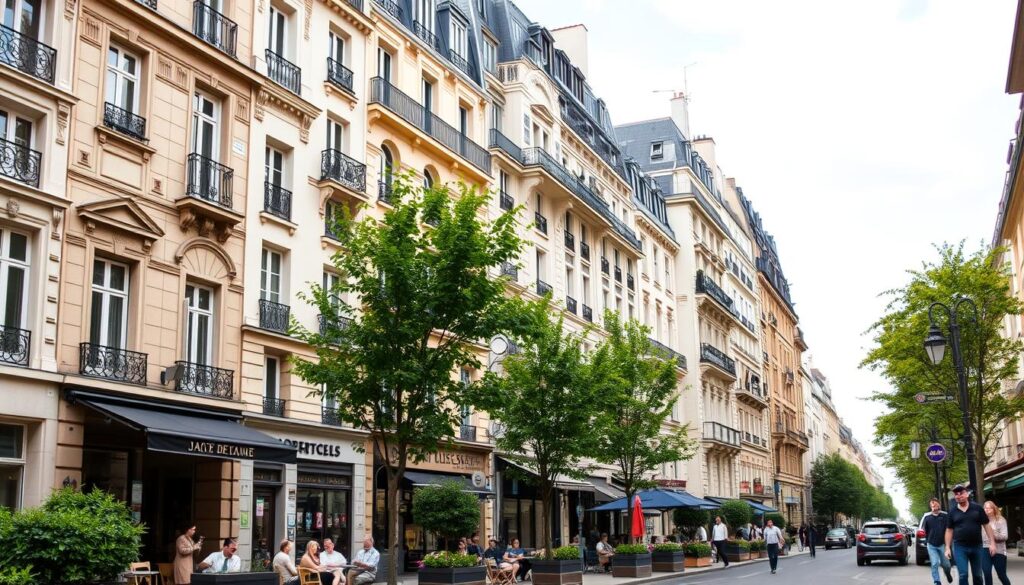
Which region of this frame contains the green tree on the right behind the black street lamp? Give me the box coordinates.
[862,244,1024,501]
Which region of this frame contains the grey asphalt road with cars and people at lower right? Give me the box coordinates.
[665,548,1024,585]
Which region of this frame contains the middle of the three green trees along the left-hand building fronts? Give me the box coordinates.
[477,299,603,558]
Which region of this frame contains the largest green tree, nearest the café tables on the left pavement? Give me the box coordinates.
[294,176,523,585]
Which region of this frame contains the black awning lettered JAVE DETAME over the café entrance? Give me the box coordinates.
[67,390,296,463]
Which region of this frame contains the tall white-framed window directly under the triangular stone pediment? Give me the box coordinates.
[89,258,128,349]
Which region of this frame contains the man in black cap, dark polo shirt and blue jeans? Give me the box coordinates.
[946,484,995,585]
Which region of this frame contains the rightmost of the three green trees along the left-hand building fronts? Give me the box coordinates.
[594,310,692,545]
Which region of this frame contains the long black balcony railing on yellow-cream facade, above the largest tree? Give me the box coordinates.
[370,77,490,174]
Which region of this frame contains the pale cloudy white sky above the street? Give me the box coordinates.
[516,0,1020,512]
